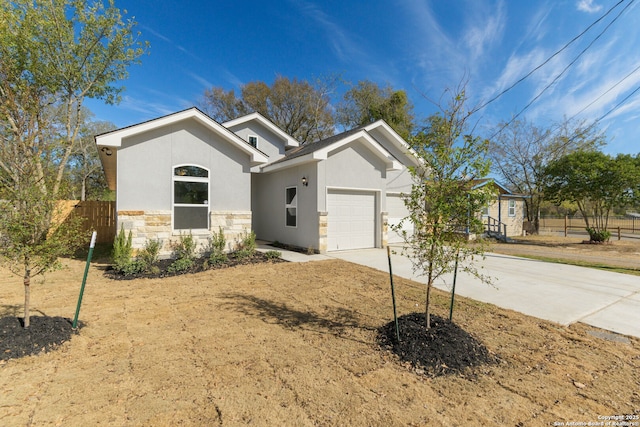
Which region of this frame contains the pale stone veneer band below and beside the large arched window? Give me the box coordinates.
[117,211,251,258]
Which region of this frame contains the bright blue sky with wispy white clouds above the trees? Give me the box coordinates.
[86,0,640,154]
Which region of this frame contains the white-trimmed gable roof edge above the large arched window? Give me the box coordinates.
[94,107,269,190]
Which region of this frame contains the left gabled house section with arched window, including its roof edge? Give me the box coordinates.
[96,110,267,254]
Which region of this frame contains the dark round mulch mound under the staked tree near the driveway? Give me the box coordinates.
[378,313,500,377]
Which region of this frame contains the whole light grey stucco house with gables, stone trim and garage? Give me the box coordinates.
[96,108,418,255]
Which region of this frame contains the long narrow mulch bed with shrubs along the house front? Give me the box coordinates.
[104,252,287,280]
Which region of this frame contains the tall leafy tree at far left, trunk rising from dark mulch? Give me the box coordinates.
[0,0,143,327]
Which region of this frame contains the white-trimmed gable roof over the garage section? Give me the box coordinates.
[261,128,401,172]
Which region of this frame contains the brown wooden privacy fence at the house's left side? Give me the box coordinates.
[59,200,116,244]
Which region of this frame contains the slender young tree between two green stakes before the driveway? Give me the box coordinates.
[395,91,493,329]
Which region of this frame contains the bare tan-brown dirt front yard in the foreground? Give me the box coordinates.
[0,239,640,426]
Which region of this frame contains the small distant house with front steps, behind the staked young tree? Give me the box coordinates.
[474,179,527,238]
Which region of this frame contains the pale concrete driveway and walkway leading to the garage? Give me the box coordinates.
[262,244,640,338]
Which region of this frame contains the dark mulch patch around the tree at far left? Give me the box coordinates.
[0,316,76,361]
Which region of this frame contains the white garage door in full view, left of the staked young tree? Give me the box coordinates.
[327,190,376,251]
